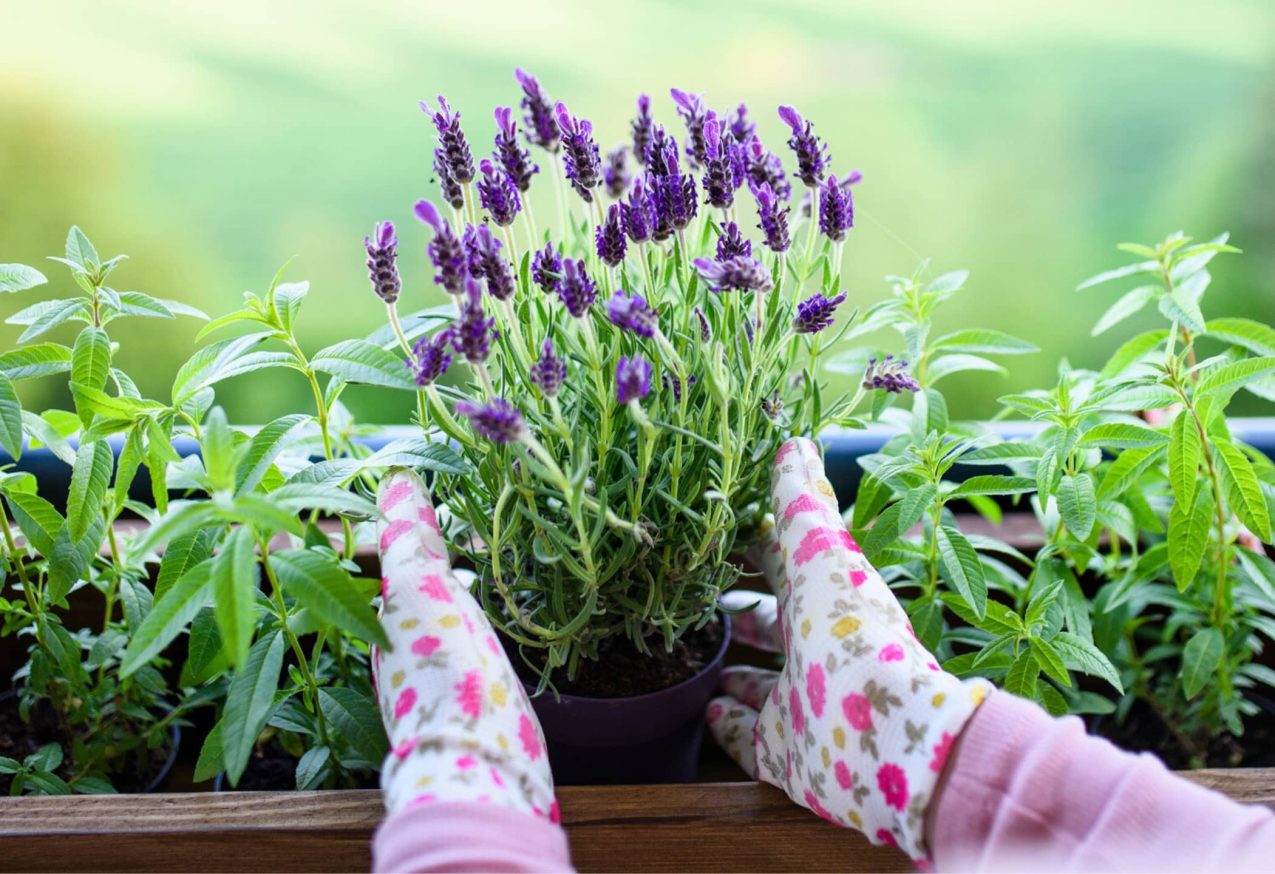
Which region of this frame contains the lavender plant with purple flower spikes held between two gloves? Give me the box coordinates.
[352,70,913,686]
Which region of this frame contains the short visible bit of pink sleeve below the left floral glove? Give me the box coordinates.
[372,801,572,871]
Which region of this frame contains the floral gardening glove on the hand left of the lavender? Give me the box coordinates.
[372,470,560,823]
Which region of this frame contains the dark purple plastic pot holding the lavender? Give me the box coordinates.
[528,615,731,786]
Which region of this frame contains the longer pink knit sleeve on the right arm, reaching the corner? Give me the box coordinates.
[932,692,1275,871]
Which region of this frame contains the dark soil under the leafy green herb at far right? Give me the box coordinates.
[1090,700,1275,769]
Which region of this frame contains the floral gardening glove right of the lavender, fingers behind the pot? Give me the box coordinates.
[708,439,991,861]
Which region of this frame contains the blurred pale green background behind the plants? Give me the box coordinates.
[0,0,1275,422]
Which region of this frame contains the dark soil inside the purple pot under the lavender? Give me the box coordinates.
[505,620,722,698]
